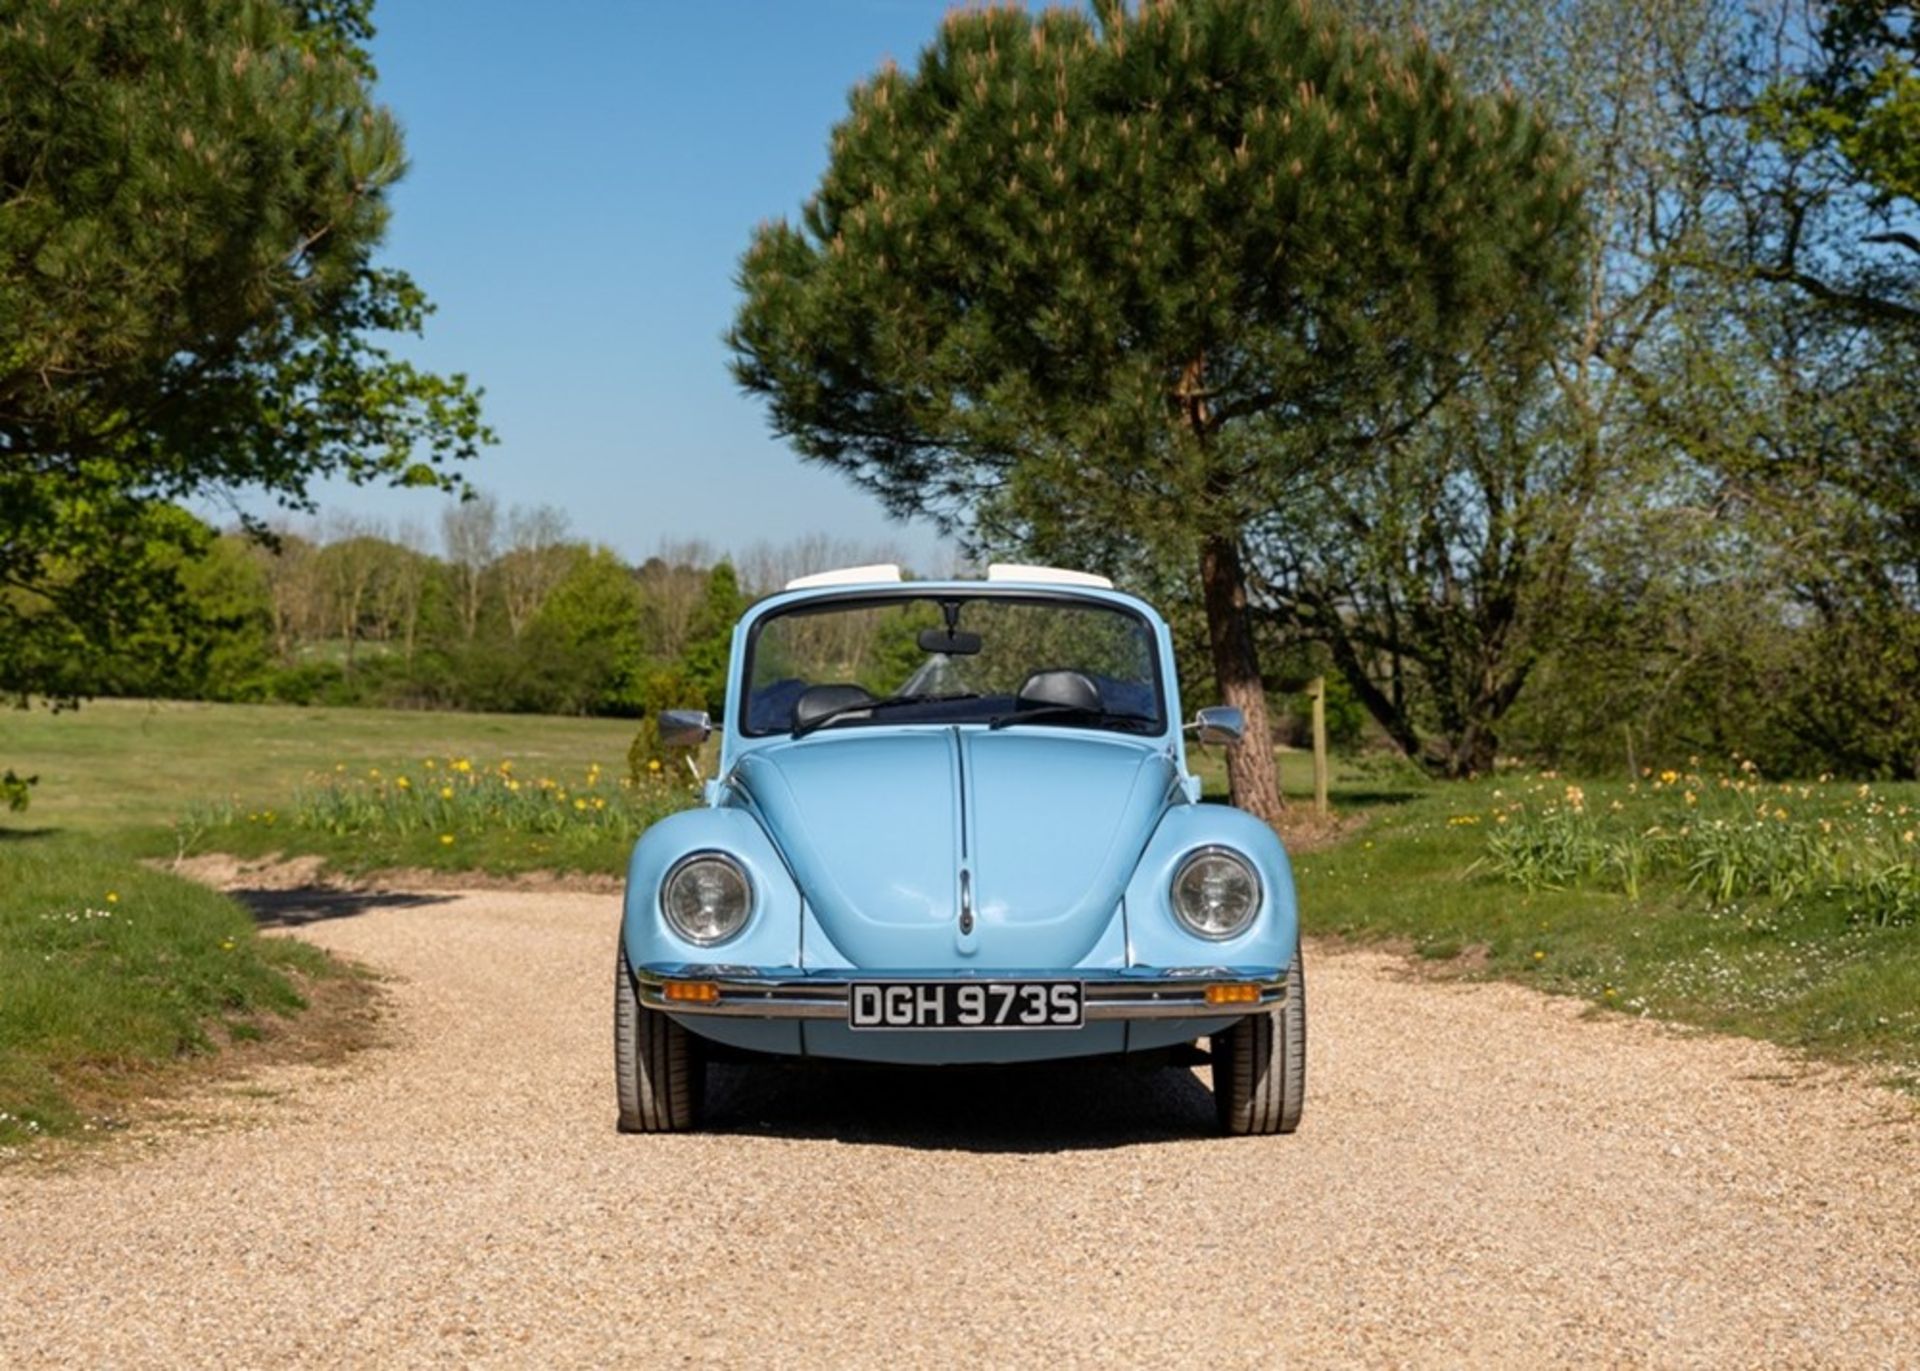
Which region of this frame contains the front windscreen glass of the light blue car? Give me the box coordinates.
[743,595,1165,735]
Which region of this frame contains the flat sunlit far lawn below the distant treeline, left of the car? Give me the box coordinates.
[0,699,648,831]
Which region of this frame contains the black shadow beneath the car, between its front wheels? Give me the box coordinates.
[701,1062,1215,1152]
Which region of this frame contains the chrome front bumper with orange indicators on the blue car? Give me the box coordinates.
[634,964,1286,1023]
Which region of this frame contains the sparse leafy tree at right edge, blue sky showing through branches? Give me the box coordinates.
[1636,0,1920,776]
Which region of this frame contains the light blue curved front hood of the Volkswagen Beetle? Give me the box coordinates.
[733,726,1177,972]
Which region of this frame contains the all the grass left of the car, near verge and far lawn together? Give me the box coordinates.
[0,701,634,1146]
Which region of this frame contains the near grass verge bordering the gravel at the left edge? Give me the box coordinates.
[0,835,346,1146]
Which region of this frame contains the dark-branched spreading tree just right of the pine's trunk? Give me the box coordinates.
[1254,371,1611,776]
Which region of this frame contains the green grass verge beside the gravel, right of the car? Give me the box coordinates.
[1296,778,1920,1085]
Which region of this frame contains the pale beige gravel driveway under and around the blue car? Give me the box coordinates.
[0,891,1920,1367]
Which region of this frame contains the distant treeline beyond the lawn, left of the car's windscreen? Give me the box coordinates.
[24,497,897,716]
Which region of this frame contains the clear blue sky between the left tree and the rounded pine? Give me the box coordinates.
[270,0,950,561]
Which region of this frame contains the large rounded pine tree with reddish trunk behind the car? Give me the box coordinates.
[732,0,1580,818]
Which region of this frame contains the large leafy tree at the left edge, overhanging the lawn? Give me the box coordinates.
[0,0,490,721]
